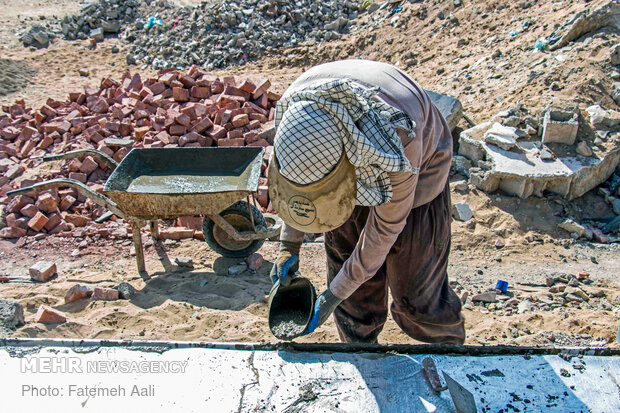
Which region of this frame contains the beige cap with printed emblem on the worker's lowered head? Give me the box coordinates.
[268,150,357,233]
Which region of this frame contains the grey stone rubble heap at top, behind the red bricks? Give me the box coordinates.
[22,0,361,69]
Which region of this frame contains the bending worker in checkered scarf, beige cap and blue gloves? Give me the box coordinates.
[268,60,465,343]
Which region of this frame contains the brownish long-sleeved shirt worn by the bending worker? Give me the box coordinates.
[281,60,452,299]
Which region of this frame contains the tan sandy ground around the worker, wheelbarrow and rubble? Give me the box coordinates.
[0,0,620,345]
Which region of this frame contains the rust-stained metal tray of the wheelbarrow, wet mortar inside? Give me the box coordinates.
[103,147,265,220]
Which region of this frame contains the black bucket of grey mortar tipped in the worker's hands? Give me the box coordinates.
[268,273,316,341]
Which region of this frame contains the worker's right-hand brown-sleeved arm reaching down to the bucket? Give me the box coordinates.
[329,167,418,300]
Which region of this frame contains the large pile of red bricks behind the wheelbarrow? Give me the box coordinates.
[0,67,280,238]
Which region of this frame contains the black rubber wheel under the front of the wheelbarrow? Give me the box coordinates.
[202,201,267,258]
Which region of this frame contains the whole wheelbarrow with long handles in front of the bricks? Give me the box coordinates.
[7,147,282,272]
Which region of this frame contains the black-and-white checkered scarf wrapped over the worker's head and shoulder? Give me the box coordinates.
[274,79,419,206]
